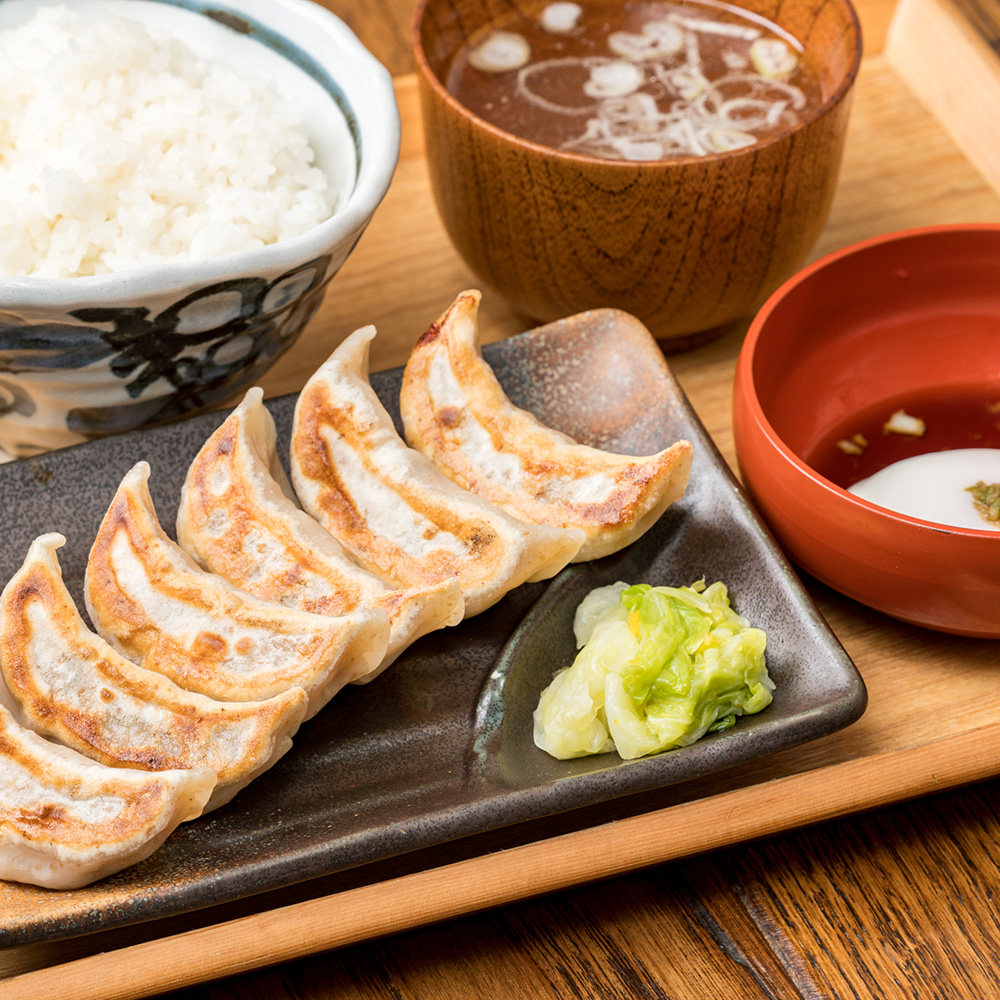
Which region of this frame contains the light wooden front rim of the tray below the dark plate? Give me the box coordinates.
[0,724,1000,1000]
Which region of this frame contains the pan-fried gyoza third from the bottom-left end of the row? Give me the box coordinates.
[84,462,389,718]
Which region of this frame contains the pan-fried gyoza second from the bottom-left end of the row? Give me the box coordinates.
[0,533,308,812]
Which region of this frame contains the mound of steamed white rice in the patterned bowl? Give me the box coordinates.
[0,6,335,278]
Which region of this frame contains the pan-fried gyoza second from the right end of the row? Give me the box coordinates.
[291,326,583,615]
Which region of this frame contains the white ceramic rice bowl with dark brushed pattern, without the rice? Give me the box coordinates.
[0,0,399,457]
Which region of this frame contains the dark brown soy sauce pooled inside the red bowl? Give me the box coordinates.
[801,382,1000,489]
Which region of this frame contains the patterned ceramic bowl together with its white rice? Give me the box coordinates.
[0,0,399,457]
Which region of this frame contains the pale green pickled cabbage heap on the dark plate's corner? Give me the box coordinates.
[534,580,774,760]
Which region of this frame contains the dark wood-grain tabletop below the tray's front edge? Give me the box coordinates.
[166,782,1000,1000]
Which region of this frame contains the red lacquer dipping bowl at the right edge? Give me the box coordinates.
[733,224,1000,638]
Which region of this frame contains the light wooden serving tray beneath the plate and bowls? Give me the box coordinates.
[0,56,1000,1000]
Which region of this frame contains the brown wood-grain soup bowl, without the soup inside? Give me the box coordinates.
[413,0,861,349]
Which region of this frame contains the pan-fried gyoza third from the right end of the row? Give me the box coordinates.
[177,388,464,682]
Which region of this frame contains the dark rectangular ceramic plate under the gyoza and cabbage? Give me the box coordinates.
[0,311,866,945]
